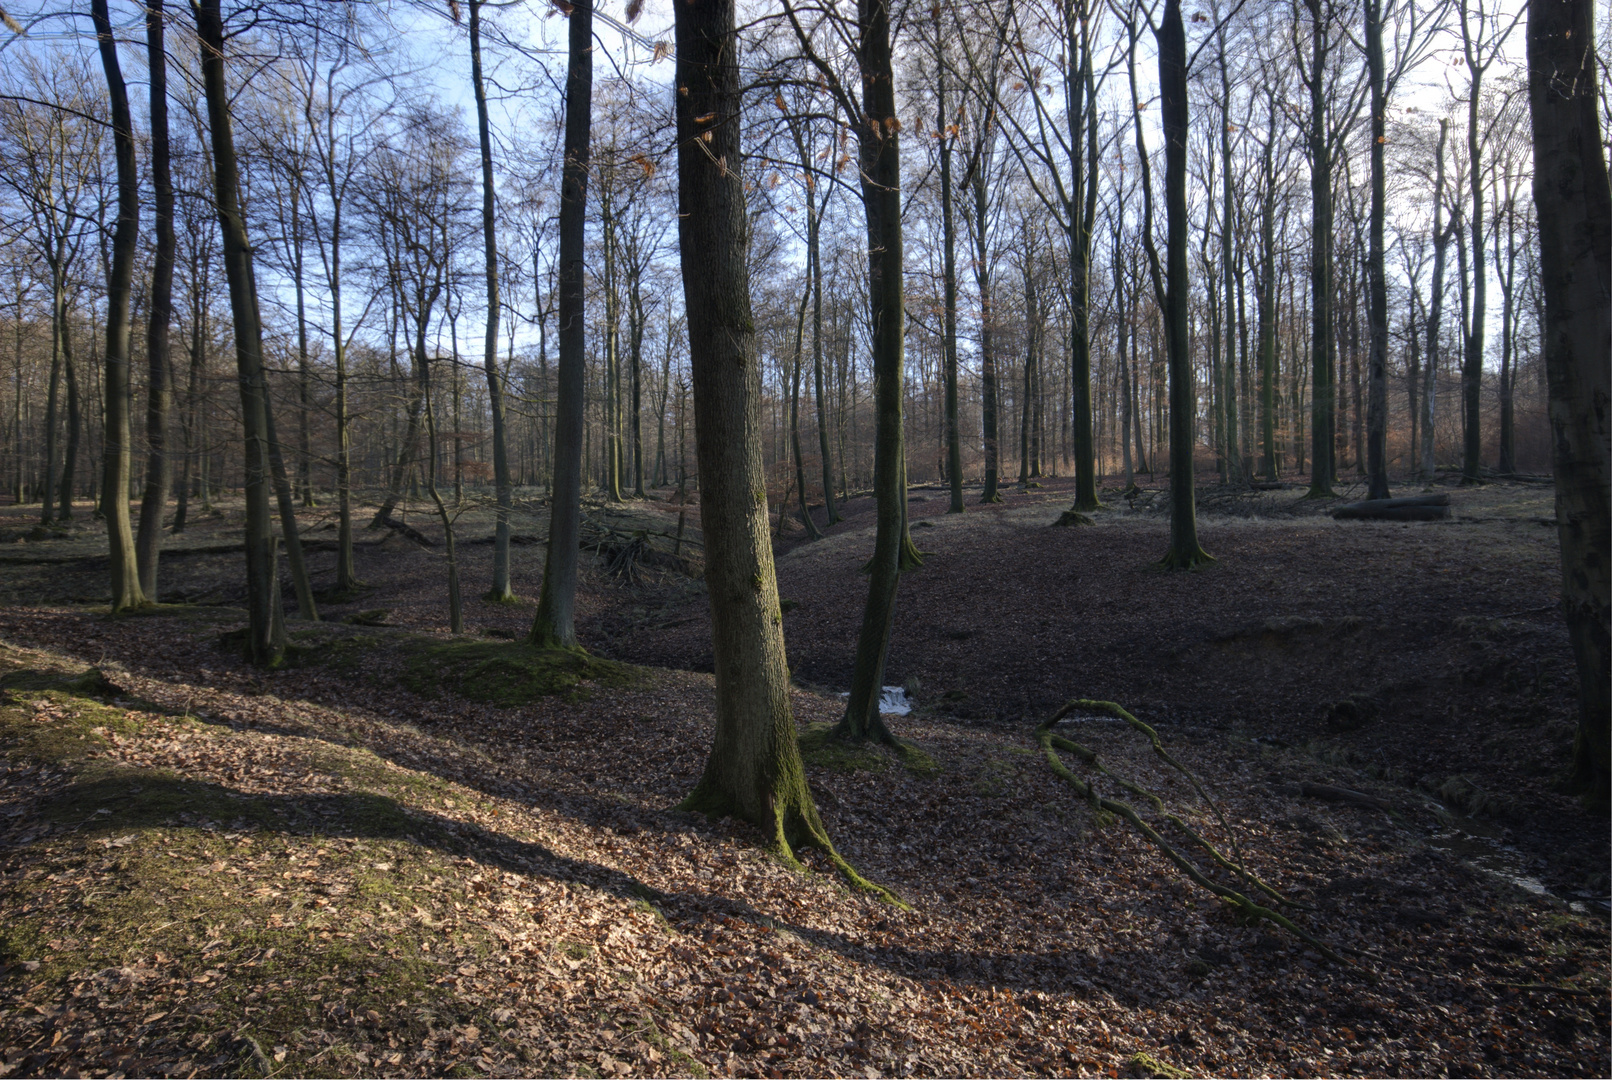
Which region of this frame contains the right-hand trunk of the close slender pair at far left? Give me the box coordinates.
[134,0,175,601]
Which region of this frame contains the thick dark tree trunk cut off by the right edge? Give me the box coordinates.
[1528,0,1612,803]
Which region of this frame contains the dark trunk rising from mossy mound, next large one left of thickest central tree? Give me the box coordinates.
[532,0,596,648]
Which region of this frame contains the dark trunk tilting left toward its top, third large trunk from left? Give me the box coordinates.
[196,0,284,666]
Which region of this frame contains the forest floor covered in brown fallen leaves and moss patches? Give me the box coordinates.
[0,479,1612,1077]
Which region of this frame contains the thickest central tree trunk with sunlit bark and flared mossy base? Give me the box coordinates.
[674,0,827,856]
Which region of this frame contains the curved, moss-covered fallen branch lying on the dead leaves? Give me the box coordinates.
[1035,700,1375,980]
